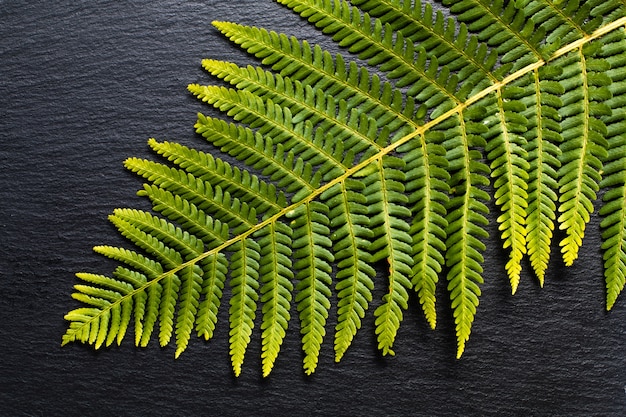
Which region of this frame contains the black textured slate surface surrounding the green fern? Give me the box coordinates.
[0,0,626,416]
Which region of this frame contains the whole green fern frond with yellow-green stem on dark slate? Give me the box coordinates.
[63,0,626,375]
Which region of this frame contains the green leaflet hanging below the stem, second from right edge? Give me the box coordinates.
[558,43,611,265]
